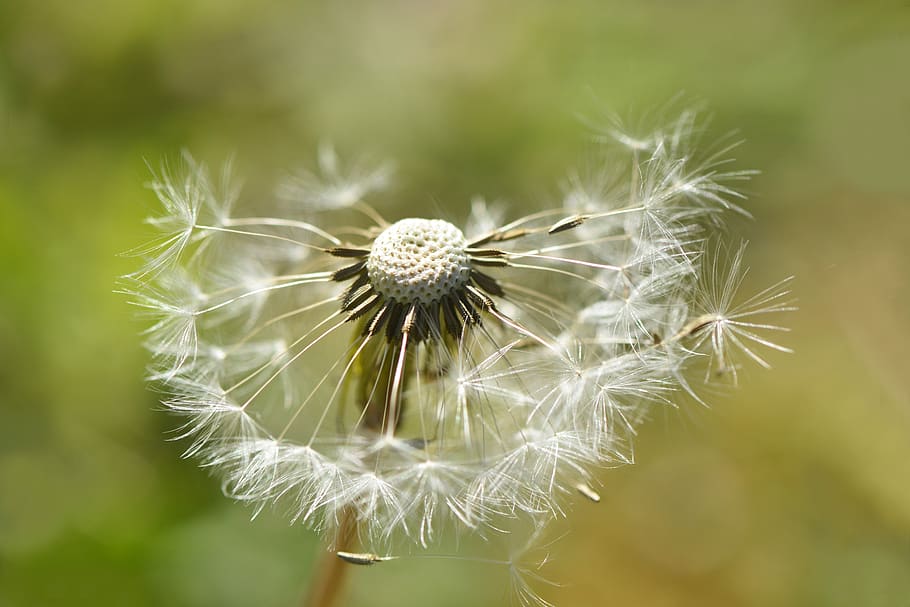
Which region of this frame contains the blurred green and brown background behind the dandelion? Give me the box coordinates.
[0,0,910,607]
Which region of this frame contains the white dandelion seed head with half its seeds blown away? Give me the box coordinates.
[126,112,791,604]
